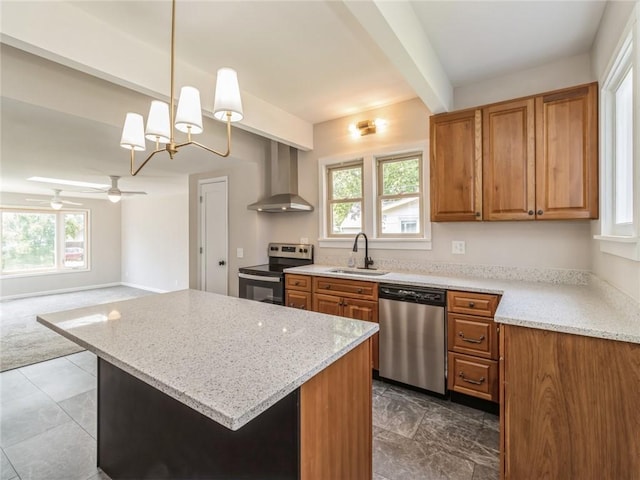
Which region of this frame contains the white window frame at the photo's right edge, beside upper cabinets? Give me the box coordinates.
[594,6,640,261]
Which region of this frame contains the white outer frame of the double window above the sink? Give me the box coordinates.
[317,142,432,250]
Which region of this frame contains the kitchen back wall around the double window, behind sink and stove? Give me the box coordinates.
[262,99,590,270]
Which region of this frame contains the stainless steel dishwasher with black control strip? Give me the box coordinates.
[378,283,447,395]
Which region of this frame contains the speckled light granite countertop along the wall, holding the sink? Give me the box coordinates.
[285,264,640,343]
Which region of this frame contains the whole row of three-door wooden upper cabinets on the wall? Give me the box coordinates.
[430,83,598,222]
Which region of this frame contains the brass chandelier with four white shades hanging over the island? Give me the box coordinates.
[120,0,243,176]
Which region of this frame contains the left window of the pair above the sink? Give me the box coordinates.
[327,161,363,236]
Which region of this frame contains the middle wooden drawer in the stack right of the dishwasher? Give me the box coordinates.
[448,313,498,360]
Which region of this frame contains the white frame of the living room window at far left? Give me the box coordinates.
[0,206,91,278]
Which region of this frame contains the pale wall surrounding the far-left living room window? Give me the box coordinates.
[0,193,121,298]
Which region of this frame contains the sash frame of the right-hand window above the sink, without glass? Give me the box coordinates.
[375,152,424,239]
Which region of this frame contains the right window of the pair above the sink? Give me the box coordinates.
[377,154,422,237]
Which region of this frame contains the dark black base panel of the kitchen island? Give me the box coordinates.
[98,358,300,480]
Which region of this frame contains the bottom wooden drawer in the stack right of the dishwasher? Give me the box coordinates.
[448,352,498,402]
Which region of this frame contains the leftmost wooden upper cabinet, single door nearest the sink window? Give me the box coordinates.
[429,110,482,222]
